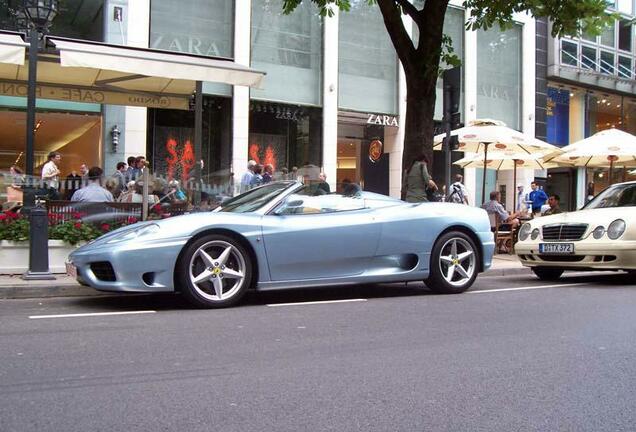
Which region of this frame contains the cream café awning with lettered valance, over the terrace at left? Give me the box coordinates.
[0,35,265,109]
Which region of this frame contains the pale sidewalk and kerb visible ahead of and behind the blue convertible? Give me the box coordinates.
[0,255,530,299]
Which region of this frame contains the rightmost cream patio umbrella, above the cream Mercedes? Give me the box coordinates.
[543,129,636,183]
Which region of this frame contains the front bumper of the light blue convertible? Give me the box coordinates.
[69,238,189,292]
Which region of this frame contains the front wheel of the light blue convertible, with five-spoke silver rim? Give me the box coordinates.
[176,234,253,308]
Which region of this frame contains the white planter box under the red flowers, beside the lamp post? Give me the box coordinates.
[0,240,79,274]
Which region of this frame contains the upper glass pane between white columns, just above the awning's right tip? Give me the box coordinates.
[251,0,322,105]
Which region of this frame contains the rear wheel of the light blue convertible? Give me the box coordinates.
[424,231,481,294]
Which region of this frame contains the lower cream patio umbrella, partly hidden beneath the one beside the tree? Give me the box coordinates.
[454,151,555,209]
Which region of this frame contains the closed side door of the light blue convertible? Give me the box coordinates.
[262,195,381,281]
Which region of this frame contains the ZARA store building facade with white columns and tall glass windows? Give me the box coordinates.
[0,0,536,203]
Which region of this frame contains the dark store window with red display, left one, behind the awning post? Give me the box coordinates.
[147,97,232,190]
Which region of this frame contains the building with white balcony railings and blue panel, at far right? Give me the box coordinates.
[541,0,636,209]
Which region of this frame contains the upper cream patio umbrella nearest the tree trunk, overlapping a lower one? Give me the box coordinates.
[433,119,559,202]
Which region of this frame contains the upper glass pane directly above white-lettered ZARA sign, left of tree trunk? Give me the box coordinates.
[338,0,398,114]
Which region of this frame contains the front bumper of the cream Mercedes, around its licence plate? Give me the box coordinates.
[515,240,636,270]
